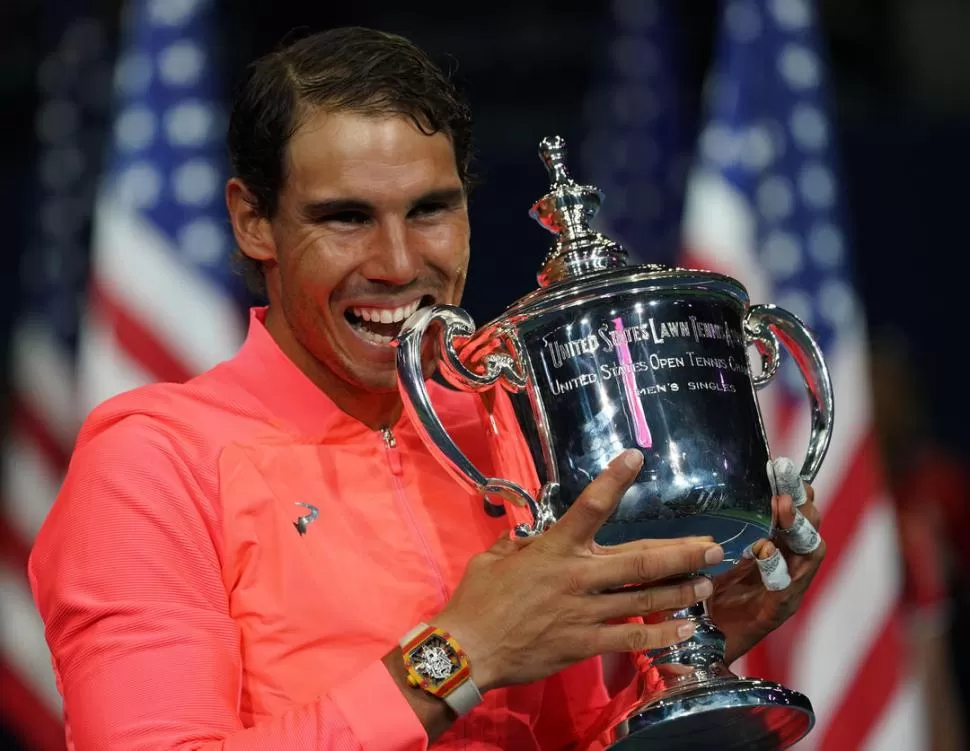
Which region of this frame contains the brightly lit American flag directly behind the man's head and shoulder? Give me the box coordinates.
[79,0,244,413]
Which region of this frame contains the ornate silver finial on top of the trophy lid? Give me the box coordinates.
[529,136,626,287]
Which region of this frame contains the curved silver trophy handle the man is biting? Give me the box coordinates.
[395,305,546,531]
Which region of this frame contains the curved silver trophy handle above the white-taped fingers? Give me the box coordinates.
[744,305,835,482]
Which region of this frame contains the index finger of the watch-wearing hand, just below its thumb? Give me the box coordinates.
[580,542,724,592]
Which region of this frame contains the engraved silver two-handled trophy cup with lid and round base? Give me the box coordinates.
[397,137,833,751]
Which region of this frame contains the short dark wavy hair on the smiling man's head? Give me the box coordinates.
[227,26,472,294]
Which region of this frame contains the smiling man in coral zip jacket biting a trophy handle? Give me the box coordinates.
[30,29,821,751]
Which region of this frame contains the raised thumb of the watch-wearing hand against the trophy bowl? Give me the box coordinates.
[542,449,643,547]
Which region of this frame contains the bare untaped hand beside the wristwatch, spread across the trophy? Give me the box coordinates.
[431,450,724,691]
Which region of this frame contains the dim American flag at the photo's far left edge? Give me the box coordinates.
[0,7,111,751]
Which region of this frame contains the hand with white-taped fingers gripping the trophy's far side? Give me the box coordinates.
[711,458,825,665]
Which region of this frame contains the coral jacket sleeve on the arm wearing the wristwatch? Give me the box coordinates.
[28,418,428,751]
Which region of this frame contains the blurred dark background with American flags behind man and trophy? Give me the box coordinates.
[0,0,970,751]
